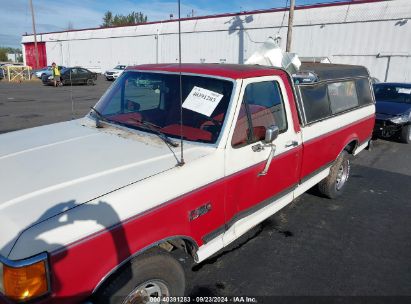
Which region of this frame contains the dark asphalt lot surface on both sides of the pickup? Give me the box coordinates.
[0,78,411,303]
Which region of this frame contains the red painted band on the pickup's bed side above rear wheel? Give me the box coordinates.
[301,115,375,178]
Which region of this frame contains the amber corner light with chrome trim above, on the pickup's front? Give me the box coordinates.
[0,253,49,301]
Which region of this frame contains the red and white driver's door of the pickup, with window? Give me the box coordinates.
[224,76,302,244]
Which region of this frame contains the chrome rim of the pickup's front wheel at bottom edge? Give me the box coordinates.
[123,280,170,304]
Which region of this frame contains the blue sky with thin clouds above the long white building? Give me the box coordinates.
[0,0,348,47]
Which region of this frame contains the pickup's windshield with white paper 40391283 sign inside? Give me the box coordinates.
[95,71,233,143]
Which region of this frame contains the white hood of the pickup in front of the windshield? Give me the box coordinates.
[0,118,211,257]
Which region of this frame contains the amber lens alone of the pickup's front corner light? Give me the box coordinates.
[3,261,48,301]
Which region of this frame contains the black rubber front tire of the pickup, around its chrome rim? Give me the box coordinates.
[95,249,185,304]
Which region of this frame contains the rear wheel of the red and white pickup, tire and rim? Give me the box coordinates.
[318,150,350,198]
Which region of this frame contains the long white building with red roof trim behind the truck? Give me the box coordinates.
[22,0,411,82]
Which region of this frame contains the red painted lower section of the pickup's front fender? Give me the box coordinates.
[51,179,226,303]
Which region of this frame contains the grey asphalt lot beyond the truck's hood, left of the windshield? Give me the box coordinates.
[0,76,112,133]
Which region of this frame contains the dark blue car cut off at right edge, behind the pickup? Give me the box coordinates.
[374,83,411,144]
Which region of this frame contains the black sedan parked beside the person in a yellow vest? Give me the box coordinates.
[41,67,97,85]
